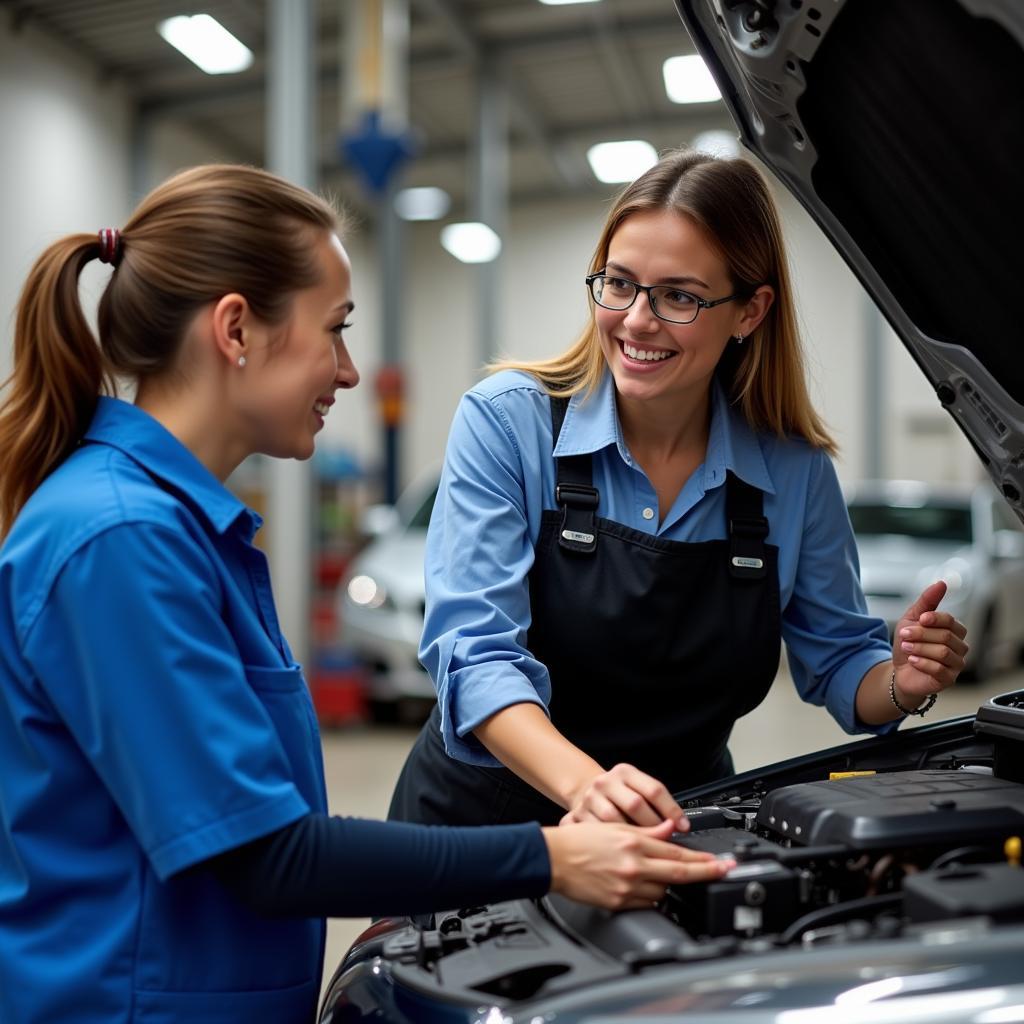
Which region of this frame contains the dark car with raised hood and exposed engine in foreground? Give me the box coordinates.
[321,0,1024,1024]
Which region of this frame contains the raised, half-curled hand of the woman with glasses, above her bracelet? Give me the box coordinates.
[893,580,968,706]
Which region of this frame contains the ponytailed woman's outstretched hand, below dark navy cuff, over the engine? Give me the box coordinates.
[542,819,735,910]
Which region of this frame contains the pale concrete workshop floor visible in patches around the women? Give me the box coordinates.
[315,670,1024,995]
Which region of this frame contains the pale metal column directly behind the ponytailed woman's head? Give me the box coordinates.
[266,0,316,663]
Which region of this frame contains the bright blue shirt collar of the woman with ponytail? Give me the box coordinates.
[85,395,256,534]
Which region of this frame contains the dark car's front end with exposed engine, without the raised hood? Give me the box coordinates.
[321,691,1024,1024]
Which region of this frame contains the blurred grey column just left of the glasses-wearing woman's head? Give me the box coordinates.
[472,60,509,368]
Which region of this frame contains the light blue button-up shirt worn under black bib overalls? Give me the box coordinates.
[420,371,896,768]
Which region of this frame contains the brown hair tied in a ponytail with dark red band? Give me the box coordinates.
[0,164,338,538]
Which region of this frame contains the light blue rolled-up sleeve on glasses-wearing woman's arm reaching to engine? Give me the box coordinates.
[420,391,551,765]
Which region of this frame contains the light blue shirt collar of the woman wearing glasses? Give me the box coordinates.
[554,371,775,494]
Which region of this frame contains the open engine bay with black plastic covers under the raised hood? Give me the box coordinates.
[325,691,1024,1004]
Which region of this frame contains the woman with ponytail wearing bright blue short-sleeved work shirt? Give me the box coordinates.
[0,166,730,1024]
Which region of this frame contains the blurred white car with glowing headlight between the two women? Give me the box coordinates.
[338,470,438,718]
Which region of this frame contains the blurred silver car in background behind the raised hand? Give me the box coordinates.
[847,480,1024,679]
